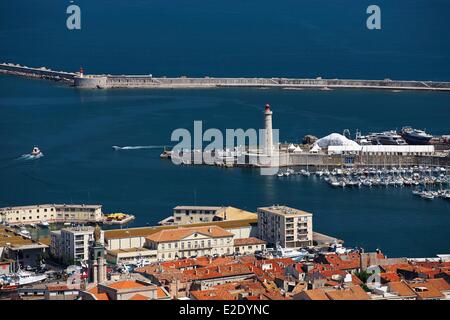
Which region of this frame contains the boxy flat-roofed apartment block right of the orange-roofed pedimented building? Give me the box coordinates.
[258,205,313,248]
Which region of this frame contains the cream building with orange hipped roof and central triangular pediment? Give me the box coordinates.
[145,225,234,261]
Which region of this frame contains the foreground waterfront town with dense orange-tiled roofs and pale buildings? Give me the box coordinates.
[0,205,450,301]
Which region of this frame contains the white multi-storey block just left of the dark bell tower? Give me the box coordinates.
[50,227,104,262]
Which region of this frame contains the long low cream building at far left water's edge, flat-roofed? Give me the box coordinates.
[0,204,102,225]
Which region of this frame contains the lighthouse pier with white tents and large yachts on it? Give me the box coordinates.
[160,104,450,174]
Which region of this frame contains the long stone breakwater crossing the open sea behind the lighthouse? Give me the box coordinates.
[0,63,450,91]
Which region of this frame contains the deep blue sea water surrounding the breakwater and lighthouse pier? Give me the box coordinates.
[0,0,450,256]
